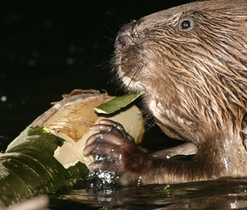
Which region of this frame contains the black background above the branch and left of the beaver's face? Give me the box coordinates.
[0,0,189,151]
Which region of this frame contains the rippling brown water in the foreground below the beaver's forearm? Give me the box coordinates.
[51,180,247,210]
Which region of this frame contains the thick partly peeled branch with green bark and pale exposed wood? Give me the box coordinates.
[0,90,144,207]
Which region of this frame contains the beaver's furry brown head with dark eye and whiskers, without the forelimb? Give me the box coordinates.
[113,0,247,144]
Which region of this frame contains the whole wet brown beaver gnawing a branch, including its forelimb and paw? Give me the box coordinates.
[84,0,247,185]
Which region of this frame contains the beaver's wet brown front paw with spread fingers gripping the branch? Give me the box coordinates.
[83,120,147,185]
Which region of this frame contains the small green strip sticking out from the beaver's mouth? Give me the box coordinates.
[94,92,143,114]
